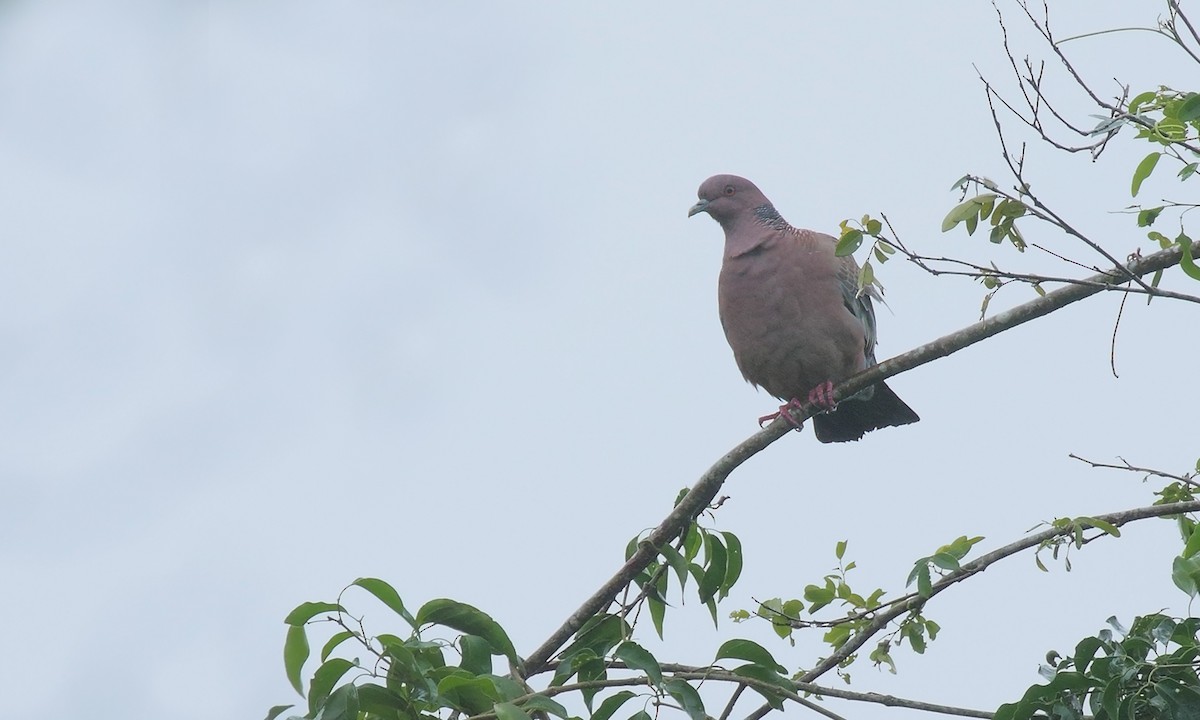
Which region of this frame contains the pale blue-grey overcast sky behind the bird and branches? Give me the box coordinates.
[0,0,1198,720]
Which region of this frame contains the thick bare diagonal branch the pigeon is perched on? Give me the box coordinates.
[524,247,1182,677]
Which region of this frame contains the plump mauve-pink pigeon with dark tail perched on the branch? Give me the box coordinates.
[688,175,920,443]
